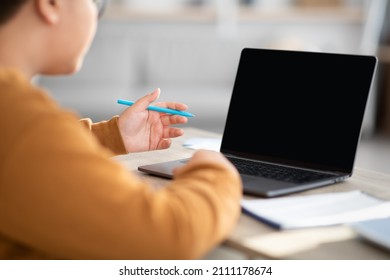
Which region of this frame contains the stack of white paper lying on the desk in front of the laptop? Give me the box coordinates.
[241,191,390,229]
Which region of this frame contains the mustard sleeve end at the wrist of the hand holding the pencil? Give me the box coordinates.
[80,116,127,155]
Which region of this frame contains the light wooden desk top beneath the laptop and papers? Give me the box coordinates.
[115,128,390,260]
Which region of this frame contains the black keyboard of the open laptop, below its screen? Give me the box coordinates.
[228,157,334,183]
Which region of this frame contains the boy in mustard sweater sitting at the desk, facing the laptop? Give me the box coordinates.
[0,0,242,259]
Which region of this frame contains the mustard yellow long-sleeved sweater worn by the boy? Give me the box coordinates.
[0,69,241,259]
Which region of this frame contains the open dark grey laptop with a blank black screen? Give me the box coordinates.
[138,48,377,197]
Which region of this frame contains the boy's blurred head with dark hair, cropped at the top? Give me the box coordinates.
[0,0,105,76]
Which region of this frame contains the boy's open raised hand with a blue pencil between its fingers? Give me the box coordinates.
[118,89,188,153]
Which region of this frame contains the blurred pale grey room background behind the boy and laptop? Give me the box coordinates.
[38,0,390,136]
